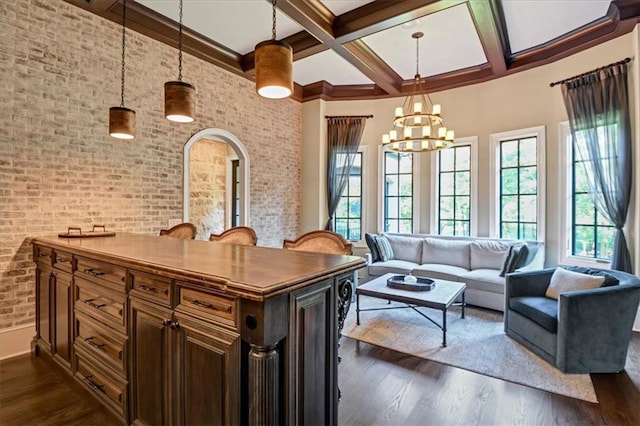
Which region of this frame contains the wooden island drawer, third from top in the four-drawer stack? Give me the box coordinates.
[76,312,127,375]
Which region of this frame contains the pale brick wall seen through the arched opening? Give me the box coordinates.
[189,139,229,240]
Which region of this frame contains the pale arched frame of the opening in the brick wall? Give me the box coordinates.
[182,128,250,239]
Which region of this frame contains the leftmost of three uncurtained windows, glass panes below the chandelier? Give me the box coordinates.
[383,151,413,233]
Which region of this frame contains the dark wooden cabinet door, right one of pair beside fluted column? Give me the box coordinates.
[171,313,240,425]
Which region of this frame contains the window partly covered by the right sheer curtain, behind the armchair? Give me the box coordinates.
[560,122,616,266]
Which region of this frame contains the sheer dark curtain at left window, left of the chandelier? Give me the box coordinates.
[325,116,368,231]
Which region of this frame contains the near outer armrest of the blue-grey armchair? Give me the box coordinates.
[556,284,640,373]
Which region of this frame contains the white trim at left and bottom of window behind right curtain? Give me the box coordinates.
[558,121,611,269]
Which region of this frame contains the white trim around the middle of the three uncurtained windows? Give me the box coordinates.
[429,136,478,237]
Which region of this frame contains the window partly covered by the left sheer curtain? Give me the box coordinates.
[333,152,363,241]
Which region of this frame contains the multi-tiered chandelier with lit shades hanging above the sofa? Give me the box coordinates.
[382,32,454,153]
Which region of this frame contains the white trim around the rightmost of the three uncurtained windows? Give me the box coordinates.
[489,126,547,241]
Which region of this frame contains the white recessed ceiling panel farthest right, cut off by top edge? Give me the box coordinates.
[502,0,610,53]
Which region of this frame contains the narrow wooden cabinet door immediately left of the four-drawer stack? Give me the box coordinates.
[52,271,73,368]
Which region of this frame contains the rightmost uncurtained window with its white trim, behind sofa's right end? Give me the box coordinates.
[491,127,545,240]
